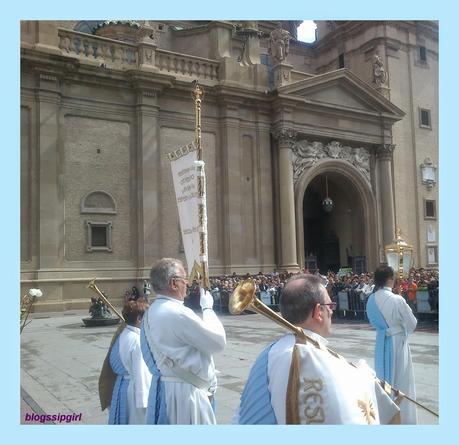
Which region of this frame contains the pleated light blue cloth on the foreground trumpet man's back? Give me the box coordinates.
[239,343,277,425]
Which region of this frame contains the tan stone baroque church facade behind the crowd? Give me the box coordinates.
[21,20,439,311]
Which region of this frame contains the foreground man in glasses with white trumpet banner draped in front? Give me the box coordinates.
[233,274,397,425]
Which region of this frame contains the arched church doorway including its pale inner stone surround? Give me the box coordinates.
[295,159,380,273]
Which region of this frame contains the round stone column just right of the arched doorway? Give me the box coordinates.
[376,144,395,247]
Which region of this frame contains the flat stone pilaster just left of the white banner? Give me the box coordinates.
[136,89,161,276]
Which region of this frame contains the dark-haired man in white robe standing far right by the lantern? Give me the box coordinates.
[366,266,417,424]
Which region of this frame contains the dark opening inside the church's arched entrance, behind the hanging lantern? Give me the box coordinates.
[303,171,366,273]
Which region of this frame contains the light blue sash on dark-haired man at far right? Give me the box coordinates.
[367,293,394,385]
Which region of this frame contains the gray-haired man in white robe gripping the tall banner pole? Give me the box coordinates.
[141,258,226,425]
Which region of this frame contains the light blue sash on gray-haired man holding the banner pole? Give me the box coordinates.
[140,320,169,425]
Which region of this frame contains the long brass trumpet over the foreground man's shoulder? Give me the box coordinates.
[228,279,438,417]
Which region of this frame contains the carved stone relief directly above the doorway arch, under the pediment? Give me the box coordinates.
[293,140,371,184]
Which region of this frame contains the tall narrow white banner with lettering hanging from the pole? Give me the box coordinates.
[168,142,201,277]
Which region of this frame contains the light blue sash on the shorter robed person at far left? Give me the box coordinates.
[108,337,129,425]
